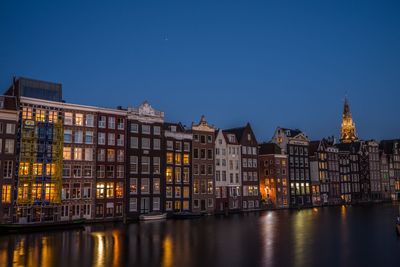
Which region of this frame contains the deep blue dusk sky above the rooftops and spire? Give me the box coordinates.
[0,0,400,141]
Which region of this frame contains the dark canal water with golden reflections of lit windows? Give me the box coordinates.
[0,204,400,267]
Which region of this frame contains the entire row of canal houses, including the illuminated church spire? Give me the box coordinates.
[0,78,400,222]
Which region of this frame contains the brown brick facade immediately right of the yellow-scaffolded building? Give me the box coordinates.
[60,104,97,221]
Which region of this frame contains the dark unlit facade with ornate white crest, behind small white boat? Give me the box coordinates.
[125,102,162,219]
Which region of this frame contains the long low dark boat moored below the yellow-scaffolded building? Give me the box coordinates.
[0,219,86,234]
